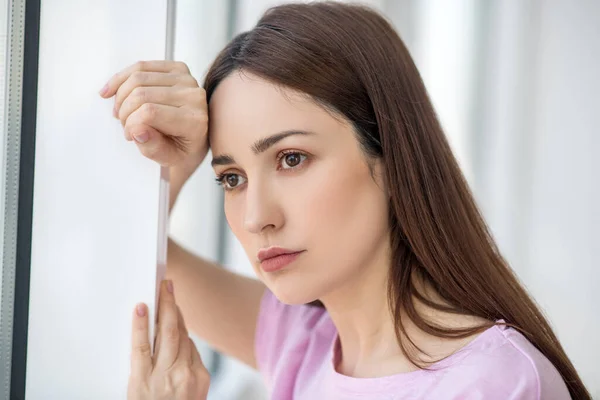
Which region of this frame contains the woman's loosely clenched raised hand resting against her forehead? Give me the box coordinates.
[100,61,208,178]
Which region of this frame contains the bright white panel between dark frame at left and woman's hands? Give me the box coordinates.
[24,0,166,400]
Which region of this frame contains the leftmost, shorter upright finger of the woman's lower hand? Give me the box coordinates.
[131,304,152,377]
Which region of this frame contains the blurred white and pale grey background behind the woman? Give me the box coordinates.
[171,0,600,399]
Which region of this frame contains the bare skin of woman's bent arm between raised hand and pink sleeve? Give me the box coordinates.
[167,171,265,368]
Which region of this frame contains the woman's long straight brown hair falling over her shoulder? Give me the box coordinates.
[204,2,591,399]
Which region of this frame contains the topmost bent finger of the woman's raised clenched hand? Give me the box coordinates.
[113,71,198,117]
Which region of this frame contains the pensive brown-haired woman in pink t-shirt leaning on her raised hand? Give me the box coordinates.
[102,2,590,400]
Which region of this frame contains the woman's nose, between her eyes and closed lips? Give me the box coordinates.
[244,182,283,234]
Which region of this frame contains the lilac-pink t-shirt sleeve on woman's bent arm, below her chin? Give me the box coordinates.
[254,289,324,385]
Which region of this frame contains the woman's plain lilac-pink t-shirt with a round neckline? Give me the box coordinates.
[255,289,571,400]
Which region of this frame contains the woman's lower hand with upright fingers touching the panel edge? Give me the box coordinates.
[127,281,210,400]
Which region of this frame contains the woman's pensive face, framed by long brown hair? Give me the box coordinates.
[209,72,389,304]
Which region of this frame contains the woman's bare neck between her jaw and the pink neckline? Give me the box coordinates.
[321,244,485,378]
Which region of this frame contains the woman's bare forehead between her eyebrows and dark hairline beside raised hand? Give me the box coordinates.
[209,71,340,149]
